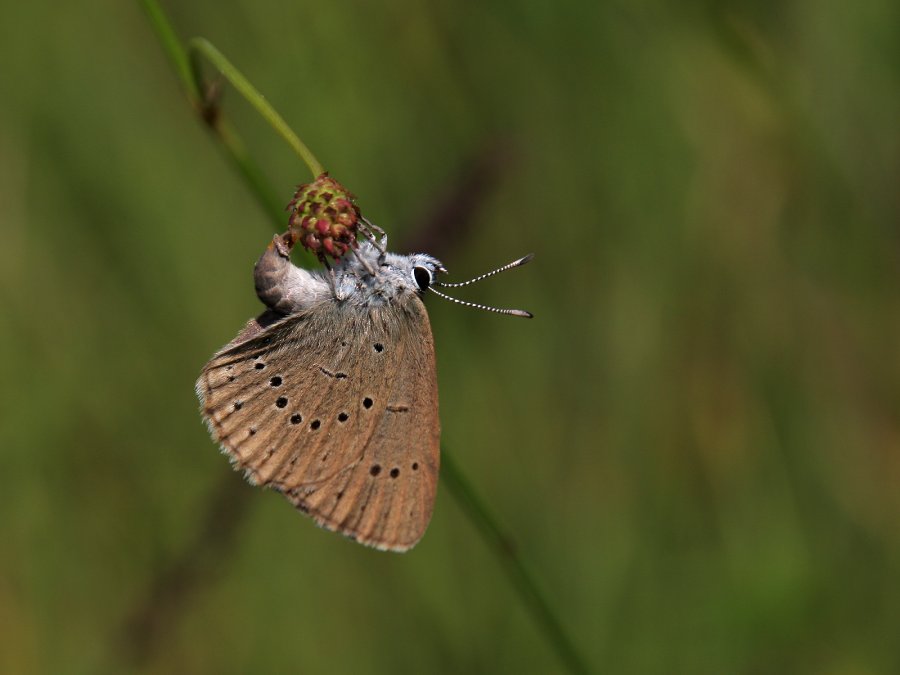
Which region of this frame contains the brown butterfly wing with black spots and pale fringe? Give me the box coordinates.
[197,295,440,551]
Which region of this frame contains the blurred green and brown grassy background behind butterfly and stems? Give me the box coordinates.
[0,0,900,674]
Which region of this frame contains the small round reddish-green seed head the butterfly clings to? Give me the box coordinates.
[288,173,362,260]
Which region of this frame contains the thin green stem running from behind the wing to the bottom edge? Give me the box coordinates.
[441,448,590,674]
